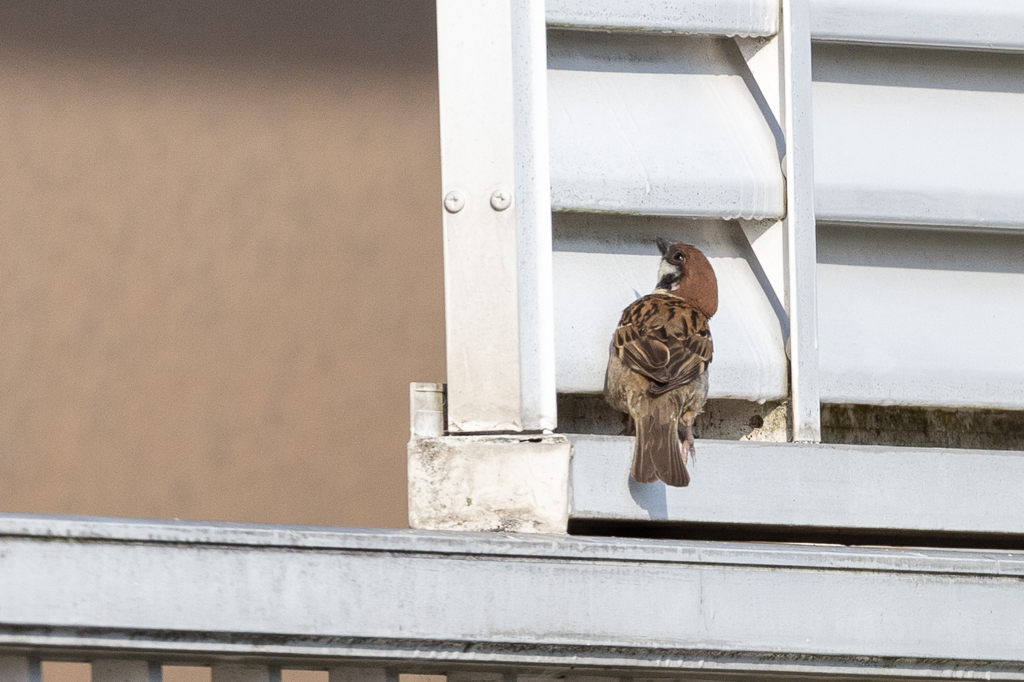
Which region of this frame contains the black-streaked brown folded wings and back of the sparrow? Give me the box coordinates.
[614,294,714,395]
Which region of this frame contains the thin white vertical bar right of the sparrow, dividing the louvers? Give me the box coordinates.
[781,0,821,442]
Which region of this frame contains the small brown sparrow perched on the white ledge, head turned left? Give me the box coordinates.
[604,239,718,486]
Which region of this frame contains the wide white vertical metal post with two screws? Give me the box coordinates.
[437,0,555,433]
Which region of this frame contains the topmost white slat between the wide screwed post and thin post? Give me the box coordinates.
[547,0,778,36]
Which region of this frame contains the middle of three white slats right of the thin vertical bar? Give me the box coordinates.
[814,45,1024,229]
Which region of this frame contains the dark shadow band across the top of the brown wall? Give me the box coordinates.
[0,0,436,76]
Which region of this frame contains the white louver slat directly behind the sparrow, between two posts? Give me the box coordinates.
[554,214,787,400]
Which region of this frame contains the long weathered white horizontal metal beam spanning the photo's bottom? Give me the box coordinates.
[0,515,1024,680]
